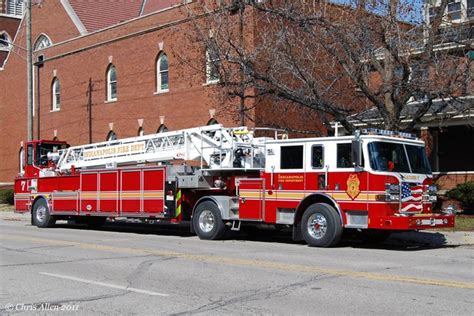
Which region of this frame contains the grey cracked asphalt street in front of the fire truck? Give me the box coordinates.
[0,211,474,315]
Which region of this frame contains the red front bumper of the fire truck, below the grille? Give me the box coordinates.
[370,213,454,230]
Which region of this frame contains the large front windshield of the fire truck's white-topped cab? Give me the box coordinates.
[369,142,431,174]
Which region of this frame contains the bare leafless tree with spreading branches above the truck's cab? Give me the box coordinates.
[177,0,473,131]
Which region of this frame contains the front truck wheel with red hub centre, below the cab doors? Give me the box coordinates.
[301,203,342,247]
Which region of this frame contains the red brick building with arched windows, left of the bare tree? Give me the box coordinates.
[0,0,326,183]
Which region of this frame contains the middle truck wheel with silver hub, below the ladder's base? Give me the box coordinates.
[193,201,225,240]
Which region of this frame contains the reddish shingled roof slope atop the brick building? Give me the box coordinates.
[69,0,183,33]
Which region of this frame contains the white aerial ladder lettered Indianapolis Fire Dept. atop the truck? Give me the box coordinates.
[57,124,266,172]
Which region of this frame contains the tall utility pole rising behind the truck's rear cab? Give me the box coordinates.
[25,0,33,141]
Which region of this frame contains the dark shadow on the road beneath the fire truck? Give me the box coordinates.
[52,222,459,251]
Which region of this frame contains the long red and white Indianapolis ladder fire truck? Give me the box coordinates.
[15,125,454,247]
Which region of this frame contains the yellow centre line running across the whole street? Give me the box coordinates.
[0,234,474,289]
